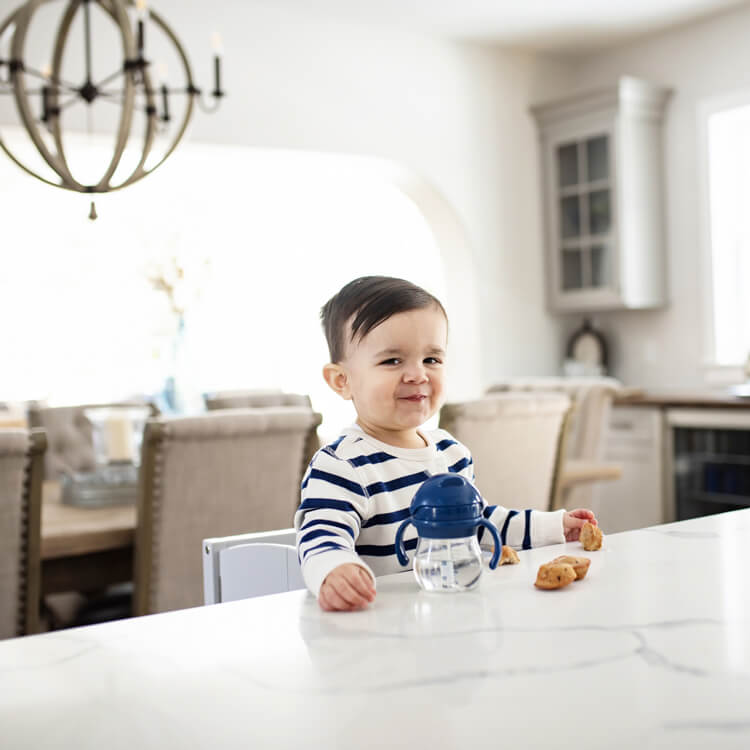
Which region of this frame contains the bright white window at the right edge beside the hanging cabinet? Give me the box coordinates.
[703,95,750,365]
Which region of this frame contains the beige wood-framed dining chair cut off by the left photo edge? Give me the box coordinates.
[0,428,47,638]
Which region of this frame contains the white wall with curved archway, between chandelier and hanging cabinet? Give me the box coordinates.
[0,0,566,397]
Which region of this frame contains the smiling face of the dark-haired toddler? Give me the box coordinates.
[341,306,448,447]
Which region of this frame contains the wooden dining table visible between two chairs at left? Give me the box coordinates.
[41,480,136,596]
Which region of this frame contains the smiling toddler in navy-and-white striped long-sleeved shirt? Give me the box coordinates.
[294,276,596,611]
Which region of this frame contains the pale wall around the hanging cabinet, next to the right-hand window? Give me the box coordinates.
[566,7,750,387]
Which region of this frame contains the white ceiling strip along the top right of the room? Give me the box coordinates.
[256,0,748,54]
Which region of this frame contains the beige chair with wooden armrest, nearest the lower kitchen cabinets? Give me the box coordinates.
[487,376,623,510]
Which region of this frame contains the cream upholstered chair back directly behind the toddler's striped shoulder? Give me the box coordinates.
[439,393,571,510]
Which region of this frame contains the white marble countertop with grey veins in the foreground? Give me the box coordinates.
[0,510,750,750]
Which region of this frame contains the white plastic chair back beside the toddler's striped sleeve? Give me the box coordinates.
[201,528,305,604]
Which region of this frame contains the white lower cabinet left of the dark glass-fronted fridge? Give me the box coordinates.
[591,406,672,534]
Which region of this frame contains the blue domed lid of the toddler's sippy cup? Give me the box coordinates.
[409,474,482,539]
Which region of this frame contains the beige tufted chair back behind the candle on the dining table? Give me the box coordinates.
[28,401,157,479]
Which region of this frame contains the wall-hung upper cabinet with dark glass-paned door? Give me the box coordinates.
[532,77,669,312]
